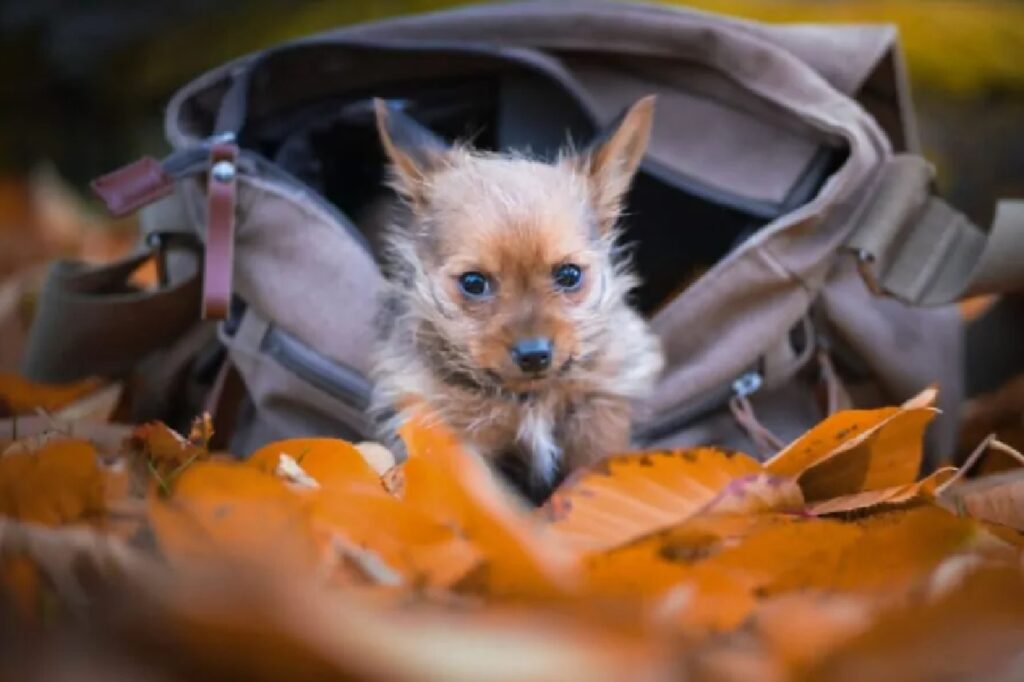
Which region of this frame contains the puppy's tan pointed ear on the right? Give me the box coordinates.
[584,95,654,233]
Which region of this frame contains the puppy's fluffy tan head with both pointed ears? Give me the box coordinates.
[377,97,654,392]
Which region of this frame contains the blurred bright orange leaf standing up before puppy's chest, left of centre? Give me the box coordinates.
[400,415,577,596]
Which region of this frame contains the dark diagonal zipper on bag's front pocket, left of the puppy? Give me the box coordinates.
[260,327,372,411]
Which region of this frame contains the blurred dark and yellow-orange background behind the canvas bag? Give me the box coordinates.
[0,0,1024,370]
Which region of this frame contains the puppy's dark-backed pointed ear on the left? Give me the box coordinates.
[374,98,447,203]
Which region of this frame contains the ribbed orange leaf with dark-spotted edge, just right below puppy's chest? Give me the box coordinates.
[542,447,763,551]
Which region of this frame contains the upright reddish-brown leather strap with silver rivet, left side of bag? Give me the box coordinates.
[203,142,239,319]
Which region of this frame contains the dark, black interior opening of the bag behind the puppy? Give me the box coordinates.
[242,60,846,315]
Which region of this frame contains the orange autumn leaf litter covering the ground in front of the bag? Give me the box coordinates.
[0,379,1024,680]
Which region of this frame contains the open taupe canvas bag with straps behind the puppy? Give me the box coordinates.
[25,1,1024,466]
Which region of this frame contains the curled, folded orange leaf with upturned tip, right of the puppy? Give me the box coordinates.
[765,388,936,501]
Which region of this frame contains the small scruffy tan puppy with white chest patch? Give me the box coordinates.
[374,96,663,503]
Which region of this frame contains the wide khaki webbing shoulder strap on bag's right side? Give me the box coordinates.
[847,154,1024,306]
